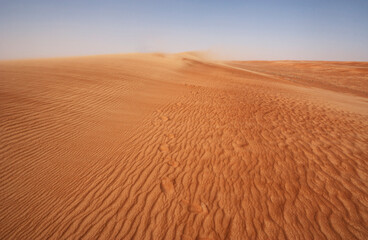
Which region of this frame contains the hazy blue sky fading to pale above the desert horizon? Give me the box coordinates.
[0,0,368,61]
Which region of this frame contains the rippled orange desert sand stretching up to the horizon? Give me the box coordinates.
[0,53,368,239]
